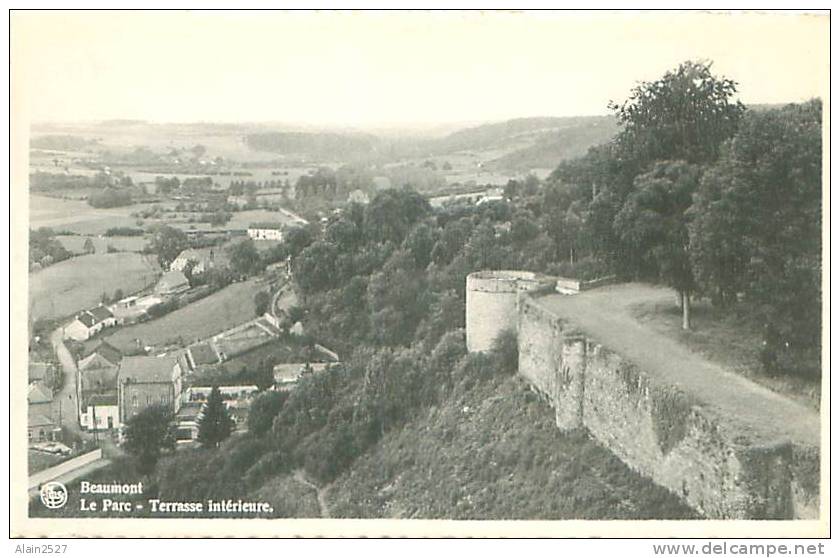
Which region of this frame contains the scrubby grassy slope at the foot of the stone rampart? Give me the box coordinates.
[328,378,692,519]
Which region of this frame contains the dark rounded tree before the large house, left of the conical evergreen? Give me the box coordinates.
[123,406,175,474]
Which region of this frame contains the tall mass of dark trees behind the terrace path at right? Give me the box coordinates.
[549,62,822,376]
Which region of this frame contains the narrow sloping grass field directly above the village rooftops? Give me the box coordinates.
[108,279,260,349]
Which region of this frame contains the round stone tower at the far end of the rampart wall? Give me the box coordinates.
[466,271,539,353]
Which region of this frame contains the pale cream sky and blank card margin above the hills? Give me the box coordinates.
[11,11,829,127]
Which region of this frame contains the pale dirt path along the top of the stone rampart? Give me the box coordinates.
[539,283,820,446]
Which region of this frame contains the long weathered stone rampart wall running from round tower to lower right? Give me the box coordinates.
[518,295,819,519]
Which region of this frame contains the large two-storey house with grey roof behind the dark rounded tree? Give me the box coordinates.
[117,353,186,423]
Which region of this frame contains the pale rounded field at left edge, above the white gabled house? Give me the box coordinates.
[29,252,160,319]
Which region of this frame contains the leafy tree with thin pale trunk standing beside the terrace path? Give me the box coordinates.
[615,161,700,329]
